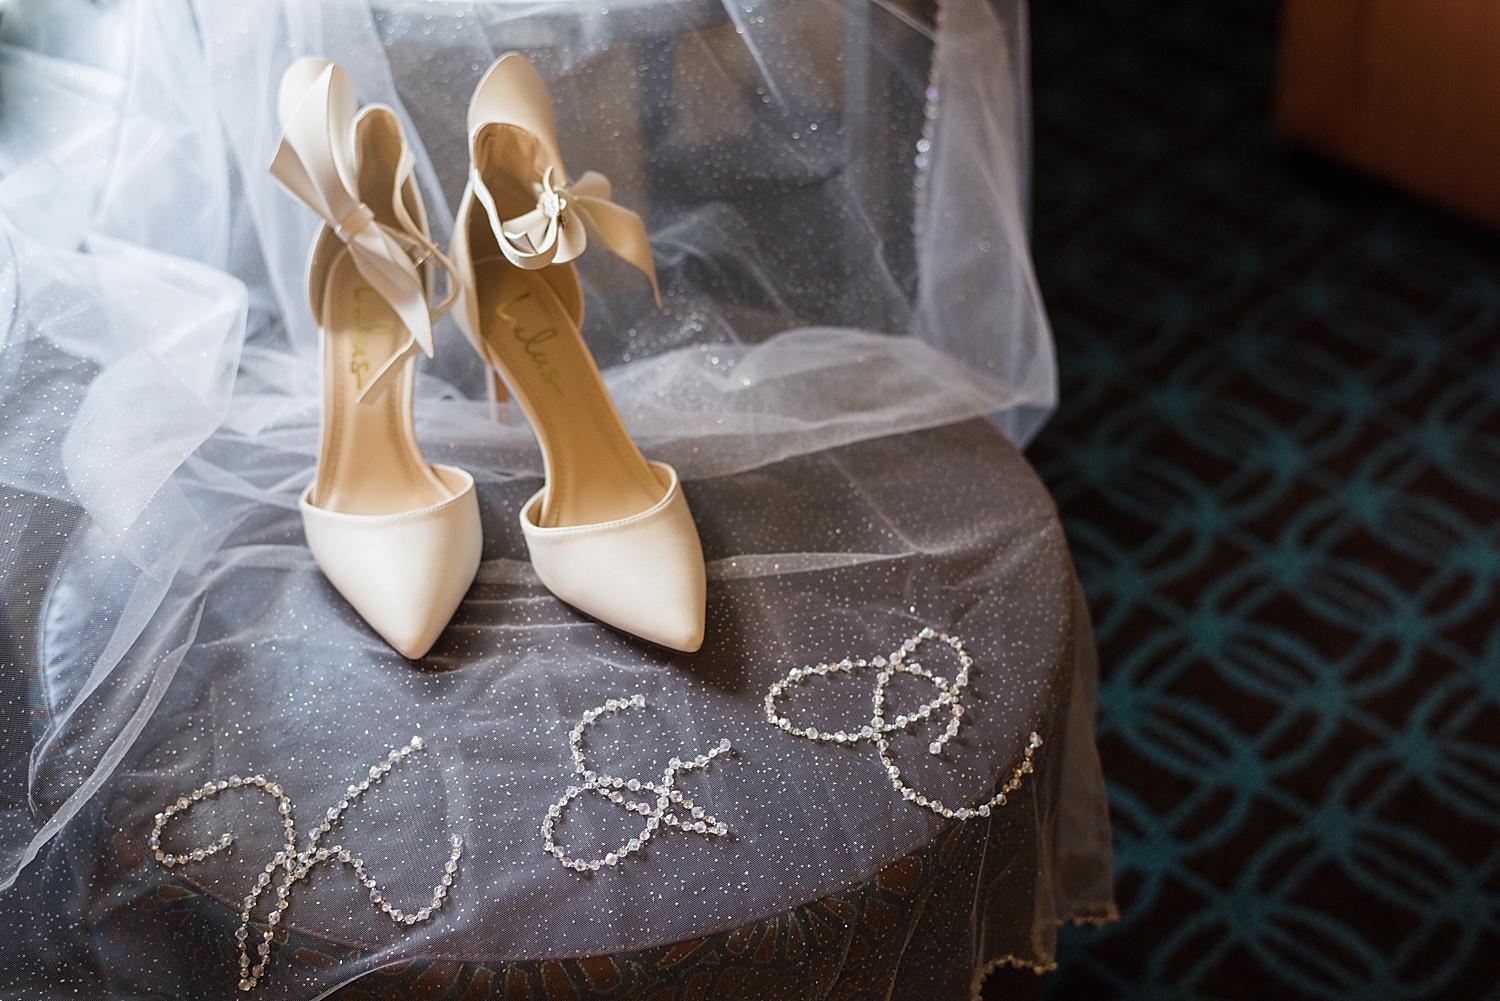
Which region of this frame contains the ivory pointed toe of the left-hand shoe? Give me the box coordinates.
[300,465,485,660]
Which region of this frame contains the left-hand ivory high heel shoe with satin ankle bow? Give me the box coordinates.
[270,59,483,659]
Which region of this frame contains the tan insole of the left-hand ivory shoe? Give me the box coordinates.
[314,251,453,515]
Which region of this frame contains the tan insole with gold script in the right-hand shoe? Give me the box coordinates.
[474,258,666,528]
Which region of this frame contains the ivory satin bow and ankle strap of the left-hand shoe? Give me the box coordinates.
[270,59,453,402]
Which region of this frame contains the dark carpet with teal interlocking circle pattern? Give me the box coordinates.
[1014,0,1500,1001]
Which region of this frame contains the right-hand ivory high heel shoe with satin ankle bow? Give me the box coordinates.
[453,53,707,651]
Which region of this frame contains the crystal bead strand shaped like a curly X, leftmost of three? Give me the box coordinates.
[150,737,464,990]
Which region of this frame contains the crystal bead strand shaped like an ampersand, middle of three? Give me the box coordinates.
[542,695,729,872]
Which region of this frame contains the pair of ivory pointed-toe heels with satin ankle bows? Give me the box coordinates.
[272,53,707,657]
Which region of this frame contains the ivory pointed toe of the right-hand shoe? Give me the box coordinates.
[521,462,708,653]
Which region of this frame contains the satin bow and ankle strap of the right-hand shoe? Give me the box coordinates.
[468,55,662,306]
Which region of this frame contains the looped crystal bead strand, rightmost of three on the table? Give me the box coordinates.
[765,627,1041,821]
